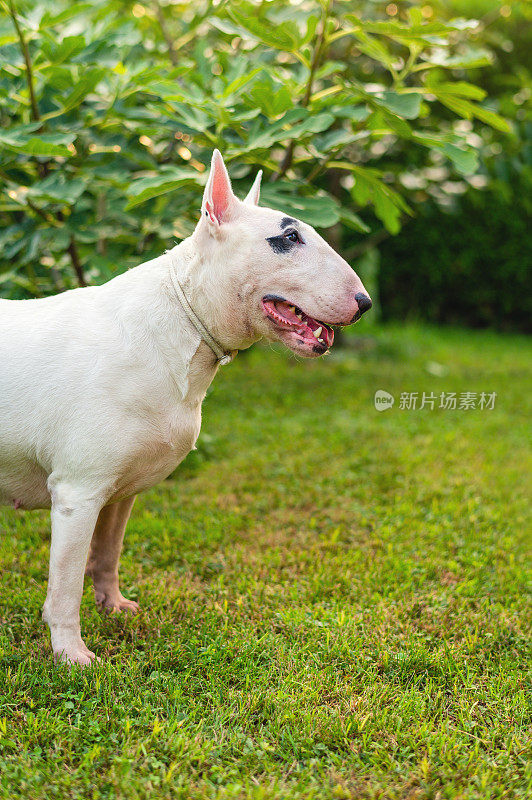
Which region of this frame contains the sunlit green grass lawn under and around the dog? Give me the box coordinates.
[0,326,532,800]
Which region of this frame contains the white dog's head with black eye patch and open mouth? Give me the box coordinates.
[193,150,371,357]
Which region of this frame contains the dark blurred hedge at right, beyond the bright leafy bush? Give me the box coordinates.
[380,0,532,331]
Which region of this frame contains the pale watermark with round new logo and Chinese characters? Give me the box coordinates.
[374,389,497,411]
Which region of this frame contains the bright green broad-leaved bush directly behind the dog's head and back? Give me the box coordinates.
[0,0,509,297]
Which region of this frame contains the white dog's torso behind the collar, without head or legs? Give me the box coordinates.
[0,248,217,508]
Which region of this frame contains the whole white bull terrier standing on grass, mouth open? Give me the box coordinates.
[0,150,371,664]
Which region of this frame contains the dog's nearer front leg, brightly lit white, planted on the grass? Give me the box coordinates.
[43,486,103,664]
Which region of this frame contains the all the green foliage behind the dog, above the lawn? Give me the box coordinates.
[0,0,532,330]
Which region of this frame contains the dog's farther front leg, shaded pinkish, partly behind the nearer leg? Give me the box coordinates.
[86,496,139,614]
